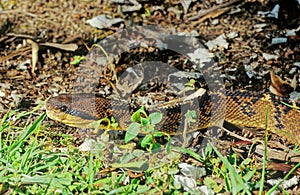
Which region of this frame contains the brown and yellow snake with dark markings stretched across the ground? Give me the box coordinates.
[46,90,300,143]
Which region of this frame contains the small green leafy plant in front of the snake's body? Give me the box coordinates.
[125,107,171,152]
